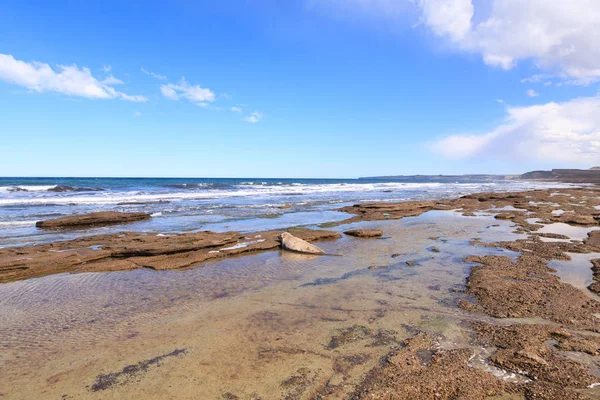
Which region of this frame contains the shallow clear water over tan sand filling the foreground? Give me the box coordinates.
[0,211,596,399]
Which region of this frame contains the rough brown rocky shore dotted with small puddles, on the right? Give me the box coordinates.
[343,189,600,399]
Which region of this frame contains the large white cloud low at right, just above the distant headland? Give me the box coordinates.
[432,96,600,167]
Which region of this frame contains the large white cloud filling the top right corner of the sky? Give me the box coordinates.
[419,0,600,84]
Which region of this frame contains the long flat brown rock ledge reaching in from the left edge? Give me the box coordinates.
[0,228,341,283]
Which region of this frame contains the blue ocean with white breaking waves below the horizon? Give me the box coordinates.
[0,178,569,247]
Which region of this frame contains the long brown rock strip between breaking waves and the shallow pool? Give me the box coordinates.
[0,188,600,284]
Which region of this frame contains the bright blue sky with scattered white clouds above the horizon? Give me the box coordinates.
[0,0,600,178]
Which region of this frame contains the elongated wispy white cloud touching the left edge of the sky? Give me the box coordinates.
[0,54,148,102]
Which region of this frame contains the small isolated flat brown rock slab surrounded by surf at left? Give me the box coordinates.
[35,211,152,229]
